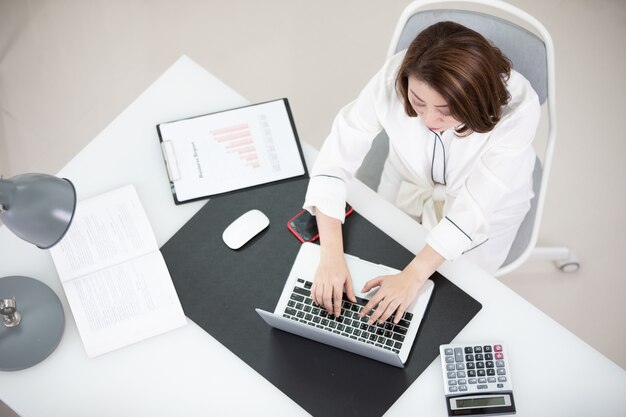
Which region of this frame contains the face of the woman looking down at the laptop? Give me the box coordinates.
[409,76,461,132]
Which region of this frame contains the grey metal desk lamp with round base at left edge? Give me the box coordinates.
[0,174,76,371]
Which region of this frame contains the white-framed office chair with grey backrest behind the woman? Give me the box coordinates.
[356,0,580,276]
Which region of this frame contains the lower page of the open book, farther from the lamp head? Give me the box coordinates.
[64,251,186,357]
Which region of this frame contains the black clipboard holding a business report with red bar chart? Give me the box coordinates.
[157,99,307,204]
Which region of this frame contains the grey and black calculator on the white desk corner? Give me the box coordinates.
[439,343,515,416]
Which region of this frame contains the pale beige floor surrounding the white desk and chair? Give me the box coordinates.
[0,0,626,415]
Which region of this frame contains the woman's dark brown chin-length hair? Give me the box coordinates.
[396,22,511,135]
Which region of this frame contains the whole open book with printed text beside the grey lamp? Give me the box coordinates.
[50,185,187,357]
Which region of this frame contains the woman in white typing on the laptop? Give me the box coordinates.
[304,22,540,324]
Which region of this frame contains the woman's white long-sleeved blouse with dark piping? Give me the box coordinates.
[304,51,540,266]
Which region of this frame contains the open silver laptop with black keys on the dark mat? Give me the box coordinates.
[256,243,434,368]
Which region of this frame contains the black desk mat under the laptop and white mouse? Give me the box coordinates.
[161,179,482,416]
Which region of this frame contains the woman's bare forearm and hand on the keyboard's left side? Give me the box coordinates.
[311,210,356,317]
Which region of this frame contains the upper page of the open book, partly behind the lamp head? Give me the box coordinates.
[50,185,158,282]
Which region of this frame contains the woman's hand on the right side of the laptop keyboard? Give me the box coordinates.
[360,271,426,324]
